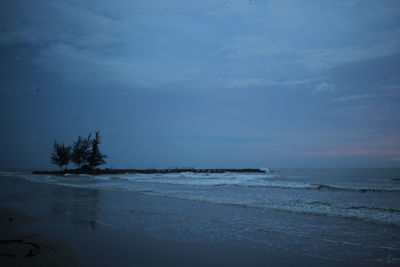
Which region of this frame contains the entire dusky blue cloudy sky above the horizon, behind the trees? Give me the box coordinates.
[0,0,400,168]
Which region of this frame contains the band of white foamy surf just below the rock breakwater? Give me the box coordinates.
[13,173,400,226]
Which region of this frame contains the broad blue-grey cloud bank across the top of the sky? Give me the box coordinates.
[0,0,400,92]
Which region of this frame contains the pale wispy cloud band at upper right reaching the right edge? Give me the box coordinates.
[215,35,400,73]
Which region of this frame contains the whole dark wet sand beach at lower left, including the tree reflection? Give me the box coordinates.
[0,177,346,266]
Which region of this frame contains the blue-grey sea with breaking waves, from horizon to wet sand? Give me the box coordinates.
[0,168,400,264]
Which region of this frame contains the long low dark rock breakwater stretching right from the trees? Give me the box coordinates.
[32,168,268,175]
